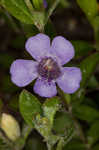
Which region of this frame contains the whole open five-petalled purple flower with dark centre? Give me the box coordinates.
[10,33,81,97]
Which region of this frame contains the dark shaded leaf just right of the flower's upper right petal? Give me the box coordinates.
[72,40,93,58]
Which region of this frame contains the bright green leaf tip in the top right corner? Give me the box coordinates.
[77,0,98,20]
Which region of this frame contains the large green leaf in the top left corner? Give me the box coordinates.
[0,0,33,24]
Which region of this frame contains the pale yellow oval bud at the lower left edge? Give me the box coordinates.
[0,113,20,141]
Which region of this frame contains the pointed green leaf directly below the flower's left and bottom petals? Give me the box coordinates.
[19,90,42,127]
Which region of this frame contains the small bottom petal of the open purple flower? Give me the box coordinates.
[34,79,57,97]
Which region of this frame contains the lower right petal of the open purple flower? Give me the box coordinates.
[57,67,82,93]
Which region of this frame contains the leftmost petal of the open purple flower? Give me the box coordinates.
[10,59,37,87]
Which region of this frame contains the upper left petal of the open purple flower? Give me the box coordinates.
[25,33,50,60]
